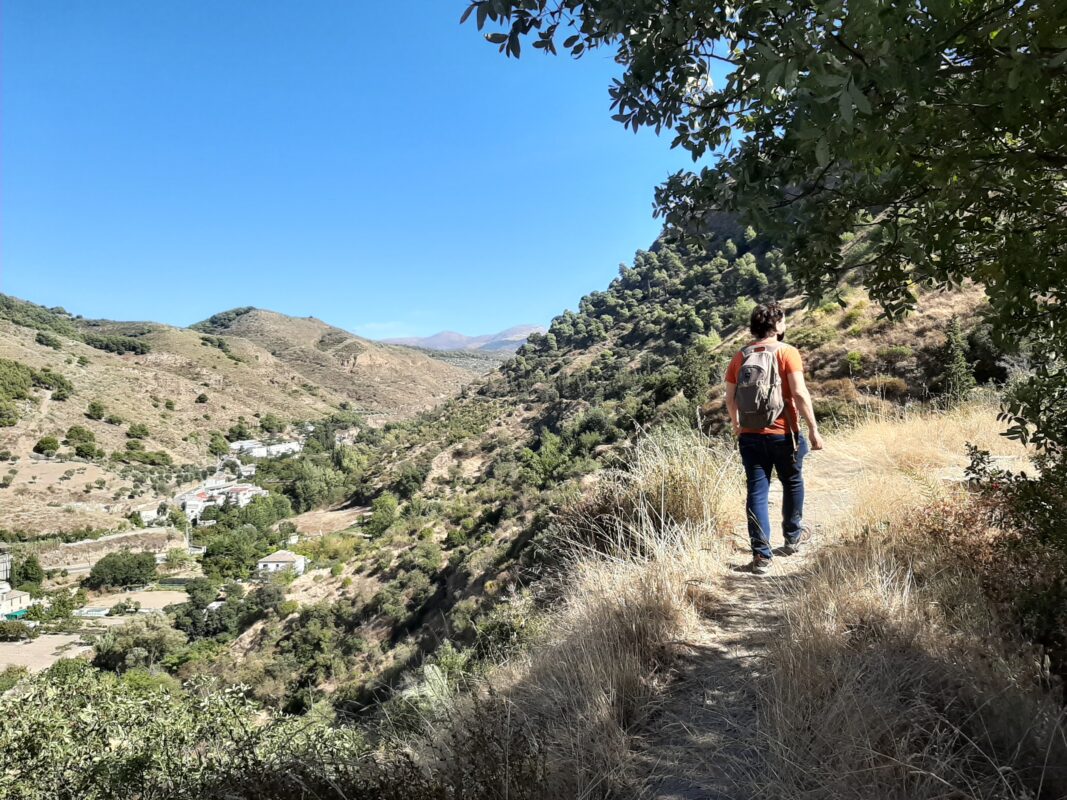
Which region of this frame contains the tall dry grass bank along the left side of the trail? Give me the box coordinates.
[403,431,738,800]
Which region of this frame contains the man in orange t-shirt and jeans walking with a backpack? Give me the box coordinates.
[727,303,823,575]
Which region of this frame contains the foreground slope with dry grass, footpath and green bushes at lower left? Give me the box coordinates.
[0,403,1067,800]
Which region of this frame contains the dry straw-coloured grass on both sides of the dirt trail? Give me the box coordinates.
[354,403,1067,800]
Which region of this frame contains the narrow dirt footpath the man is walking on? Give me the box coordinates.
[635,441,897,800]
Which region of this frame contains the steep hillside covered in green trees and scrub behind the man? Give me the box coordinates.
[164,227,1001,711]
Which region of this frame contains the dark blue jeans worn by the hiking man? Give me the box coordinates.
[737,433,809,558]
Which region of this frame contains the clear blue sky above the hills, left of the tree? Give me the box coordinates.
[0,0,689,338]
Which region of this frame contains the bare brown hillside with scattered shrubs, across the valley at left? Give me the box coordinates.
[0,295,476,533]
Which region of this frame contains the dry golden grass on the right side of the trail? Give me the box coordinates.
[752,405,1067,800]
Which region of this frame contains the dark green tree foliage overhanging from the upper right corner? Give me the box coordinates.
[463,0,1067,450]
